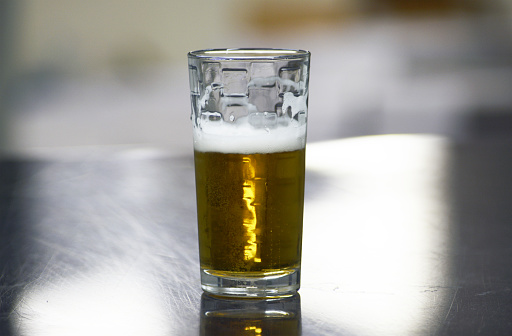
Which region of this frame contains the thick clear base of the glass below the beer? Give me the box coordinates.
[201,268,300,298]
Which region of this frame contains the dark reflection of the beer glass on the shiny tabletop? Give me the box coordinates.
[201,294,301,336]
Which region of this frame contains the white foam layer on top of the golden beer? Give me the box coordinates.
[194,120,306,154]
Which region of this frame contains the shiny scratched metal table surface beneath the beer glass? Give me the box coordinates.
[0,135,512,336]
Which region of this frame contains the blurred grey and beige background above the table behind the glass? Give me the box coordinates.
[0,0,512,155]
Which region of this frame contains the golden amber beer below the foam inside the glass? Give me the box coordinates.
[195,149,305,275]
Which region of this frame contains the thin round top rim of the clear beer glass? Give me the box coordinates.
[188,48,311,61]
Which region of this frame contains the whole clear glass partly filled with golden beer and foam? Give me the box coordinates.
[188,49,310,297]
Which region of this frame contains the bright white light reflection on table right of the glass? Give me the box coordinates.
[301,135,450,335]
